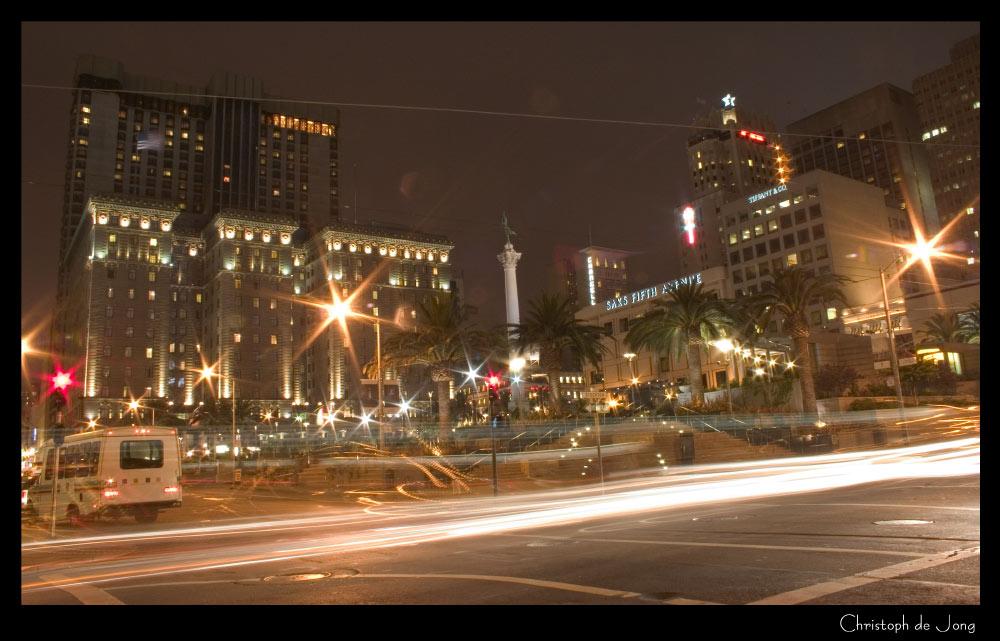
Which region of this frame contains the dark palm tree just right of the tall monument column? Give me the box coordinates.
[509,293,607,415]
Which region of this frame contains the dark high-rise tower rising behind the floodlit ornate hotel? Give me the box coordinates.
[59,55,339,298]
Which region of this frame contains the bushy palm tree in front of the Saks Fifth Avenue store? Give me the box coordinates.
[625,284,734,403]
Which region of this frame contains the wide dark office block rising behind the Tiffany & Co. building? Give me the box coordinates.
[787,83,940,236]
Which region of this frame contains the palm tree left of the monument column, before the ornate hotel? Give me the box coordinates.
[374,295,503,437]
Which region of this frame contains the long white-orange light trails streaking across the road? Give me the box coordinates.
[21,438,980,591]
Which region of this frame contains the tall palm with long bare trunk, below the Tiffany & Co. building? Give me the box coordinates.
[757,267,848,414]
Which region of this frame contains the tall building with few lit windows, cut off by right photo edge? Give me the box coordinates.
[913,33,980,264]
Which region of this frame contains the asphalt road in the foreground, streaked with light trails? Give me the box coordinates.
[21,439,980,605]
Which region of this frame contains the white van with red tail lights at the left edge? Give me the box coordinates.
[22,427,182,523]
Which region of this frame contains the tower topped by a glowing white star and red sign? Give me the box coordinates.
[674,94,780,274]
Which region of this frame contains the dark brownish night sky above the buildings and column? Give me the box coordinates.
[21,22,980,348]
